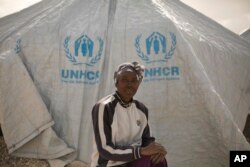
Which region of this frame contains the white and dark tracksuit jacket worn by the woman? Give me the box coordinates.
[91,93,155,167]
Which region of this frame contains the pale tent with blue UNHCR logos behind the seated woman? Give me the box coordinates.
[0,0,250,167]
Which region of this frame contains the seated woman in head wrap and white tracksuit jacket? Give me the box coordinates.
[91,62,167,167]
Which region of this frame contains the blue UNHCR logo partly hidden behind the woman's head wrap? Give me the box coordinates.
[134,32,180,81]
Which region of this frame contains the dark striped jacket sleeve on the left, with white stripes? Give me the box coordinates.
[92,103,141,161]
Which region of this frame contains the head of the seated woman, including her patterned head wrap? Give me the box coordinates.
[114,62,144,102]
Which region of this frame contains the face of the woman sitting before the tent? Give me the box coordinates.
[116,71,140,102]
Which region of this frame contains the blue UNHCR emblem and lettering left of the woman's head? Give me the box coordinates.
[60,35,103,84]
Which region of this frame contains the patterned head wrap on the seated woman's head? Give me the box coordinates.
[114,62,145,83]
